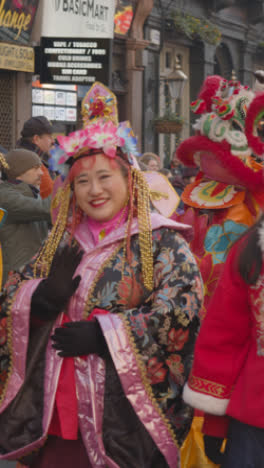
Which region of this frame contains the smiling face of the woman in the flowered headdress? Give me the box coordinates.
[74,153,128,222]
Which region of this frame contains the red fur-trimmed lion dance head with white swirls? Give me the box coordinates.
[177,76,264,196]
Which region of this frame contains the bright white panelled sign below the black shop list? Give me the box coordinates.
[32,81,77,122]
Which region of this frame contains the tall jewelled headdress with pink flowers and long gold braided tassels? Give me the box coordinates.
[35,82,153,290]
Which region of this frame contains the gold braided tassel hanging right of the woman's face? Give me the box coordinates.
[132,168,153,291]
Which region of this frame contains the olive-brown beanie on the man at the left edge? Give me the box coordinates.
[4,148,42,179]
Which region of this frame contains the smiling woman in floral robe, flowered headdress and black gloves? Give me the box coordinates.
[0,83,202,468]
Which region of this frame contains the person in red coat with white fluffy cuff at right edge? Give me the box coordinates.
[183,216,264,468]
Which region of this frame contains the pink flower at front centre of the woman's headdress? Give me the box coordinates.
[87,121,125,158]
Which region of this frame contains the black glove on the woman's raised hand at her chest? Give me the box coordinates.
[31,246,83,321]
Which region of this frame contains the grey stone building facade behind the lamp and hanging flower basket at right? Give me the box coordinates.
[142,0,264,165]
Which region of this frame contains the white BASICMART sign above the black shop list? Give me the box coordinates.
[41,0,115,39]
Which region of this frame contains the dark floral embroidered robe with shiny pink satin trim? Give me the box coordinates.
[0,214,202,468]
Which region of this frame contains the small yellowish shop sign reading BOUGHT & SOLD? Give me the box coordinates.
[0,42,35,73]
